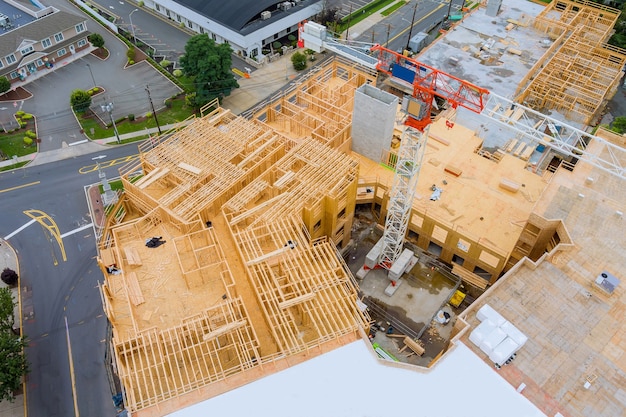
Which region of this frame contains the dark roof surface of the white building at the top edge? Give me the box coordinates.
[176,0,317,31]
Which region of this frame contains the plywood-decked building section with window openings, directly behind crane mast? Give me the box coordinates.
[357,118,546,283]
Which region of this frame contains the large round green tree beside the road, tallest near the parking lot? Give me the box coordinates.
[180,33,239,108]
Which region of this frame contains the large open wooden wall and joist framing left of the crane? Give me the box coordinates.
[98,60,374,416]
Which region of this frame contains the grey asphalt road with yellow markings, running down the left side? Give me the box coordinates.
[0,144,137,417]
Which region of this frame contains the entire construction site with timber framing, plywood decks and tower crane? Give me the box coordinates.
[98,0,626,417]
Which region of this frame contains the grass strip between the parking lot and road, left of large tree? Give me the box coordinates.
[78,99,193,141]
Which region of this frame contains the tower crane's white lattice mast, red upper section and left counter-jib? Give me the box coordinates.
[298,22,489,278]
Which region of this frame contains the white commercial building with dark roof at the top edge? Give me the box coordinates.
[144,0,323,60]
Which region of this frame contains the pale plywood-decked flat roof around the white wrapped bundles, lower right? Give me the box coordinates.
[454,127,626,417]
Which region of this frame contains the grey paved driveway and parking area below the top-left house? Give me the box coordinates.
[16,7,180,152]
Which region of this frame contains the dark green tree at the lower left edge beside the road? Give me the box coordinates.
[0,288,28,401]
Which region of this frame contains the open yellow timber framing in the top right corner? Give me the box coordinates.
[515,1,626,124]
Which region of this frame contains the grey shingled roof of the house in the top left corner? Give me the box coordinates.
[0,11,86,57]
